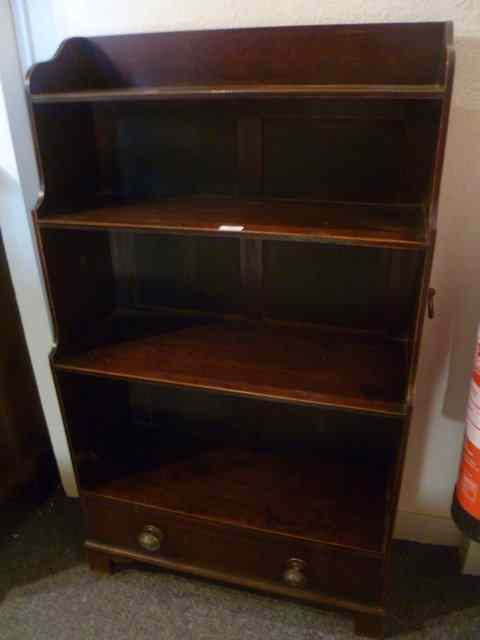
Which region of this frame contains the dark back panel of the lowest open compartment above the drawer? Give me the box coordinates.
[129,383,401,460]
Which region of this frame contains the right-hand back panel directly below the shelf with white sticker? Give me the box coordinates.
[264,242,420,335]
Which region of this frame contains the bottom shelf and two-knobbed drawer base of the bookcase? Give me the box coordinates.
[78,436,392,636]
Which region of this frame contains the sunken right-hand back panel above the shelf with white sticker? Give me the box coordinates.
[263,117,405,202]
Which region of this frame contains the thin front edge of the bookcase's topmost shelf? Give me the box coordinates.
[31,83,445,104]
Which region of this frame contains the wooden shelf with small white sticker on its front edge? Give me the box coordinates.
[39,196,426,249]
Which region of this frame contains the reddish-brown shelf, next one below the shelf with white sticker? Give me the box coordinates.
[54,316,407,416]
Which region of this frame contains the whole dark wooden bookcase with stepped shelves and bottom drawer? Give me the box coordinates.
[28,23,454,636]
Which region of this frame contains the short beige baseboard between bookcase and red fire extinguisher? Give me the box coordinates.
[394,511,462,547]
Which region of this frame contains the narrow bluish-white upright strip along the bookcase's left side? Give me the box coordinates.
[0,1,75,494]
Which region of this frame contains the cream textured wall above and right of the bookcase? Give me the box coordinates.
[17,0,480,543]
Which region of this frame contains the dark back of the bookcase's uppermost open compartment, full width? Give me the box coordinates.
[34,99,441,214]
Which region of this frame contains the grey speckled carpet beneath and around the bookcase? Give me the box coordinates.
[0,495,480,640]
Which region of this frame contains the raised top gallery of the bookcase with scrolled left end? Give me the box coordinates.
[27,22,452,102]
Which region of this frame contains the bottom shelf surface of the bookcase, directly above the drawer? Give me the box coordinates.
[83,440,392,555]
